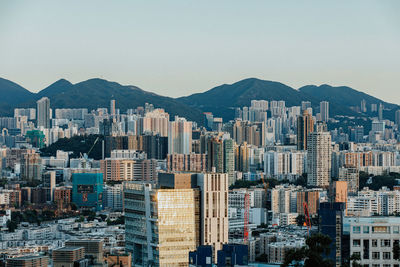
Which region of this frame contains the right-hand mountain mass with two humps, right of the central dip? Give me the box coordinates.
[178,78,399,120]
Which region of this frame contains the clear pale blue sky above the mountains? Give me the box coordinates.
[0,0,400,104]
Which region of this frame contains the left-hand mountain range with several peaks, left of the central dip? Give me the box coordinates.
[0,78,203,123]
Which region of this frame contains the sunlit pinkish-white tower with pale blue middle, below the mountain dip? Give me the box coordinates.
[168,116,192,154]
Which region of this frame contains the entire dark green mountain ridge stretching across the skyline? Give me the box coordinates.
[0,78,399,123]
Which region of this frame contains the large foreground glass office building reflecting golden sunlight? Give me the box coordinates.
[124,182,200,266]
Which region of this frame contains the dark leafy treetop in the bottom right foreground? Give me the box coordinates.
[281,233,334,267]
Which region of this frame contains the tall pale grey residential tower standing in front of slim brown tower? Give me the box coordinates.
[307,129,332,187]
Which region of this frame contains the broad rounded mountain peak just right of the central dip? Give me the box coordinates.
[178,78,316,120]
